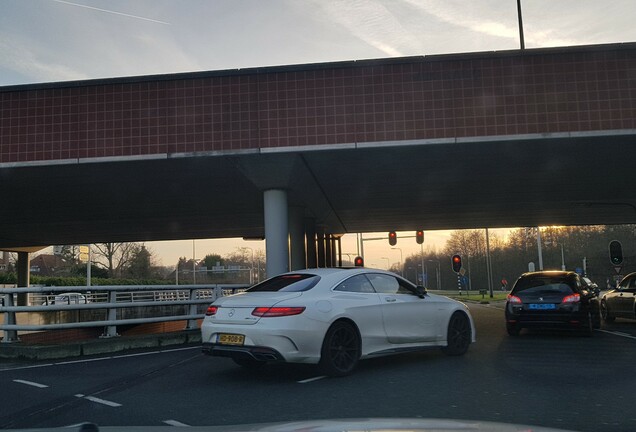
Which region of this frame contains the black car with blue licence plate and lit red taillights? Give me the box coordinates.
[506,271,601,336]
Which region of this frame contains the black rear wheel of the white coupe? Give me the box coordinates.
[320,321,361,376]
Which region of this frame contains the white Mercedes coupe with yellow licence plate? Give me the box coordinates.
[201,267,475,376]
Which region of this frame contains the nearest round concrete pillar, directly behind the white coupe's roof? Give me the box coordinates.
[263,189,289,277]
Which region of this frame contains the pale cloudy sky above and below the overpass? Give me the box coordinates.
[0,0,636,268]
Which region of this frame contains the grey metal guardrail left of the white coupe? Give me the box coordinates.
[0,284,249,343]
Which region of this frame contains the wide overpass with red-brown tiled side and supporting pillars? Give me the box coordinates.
[0,43,636,271]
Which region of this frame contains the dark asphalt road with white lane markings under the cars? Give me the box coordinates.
[0,304,636,432]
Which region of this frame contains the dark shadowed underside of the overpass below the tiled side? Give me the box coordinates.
[0,130,636,250]
